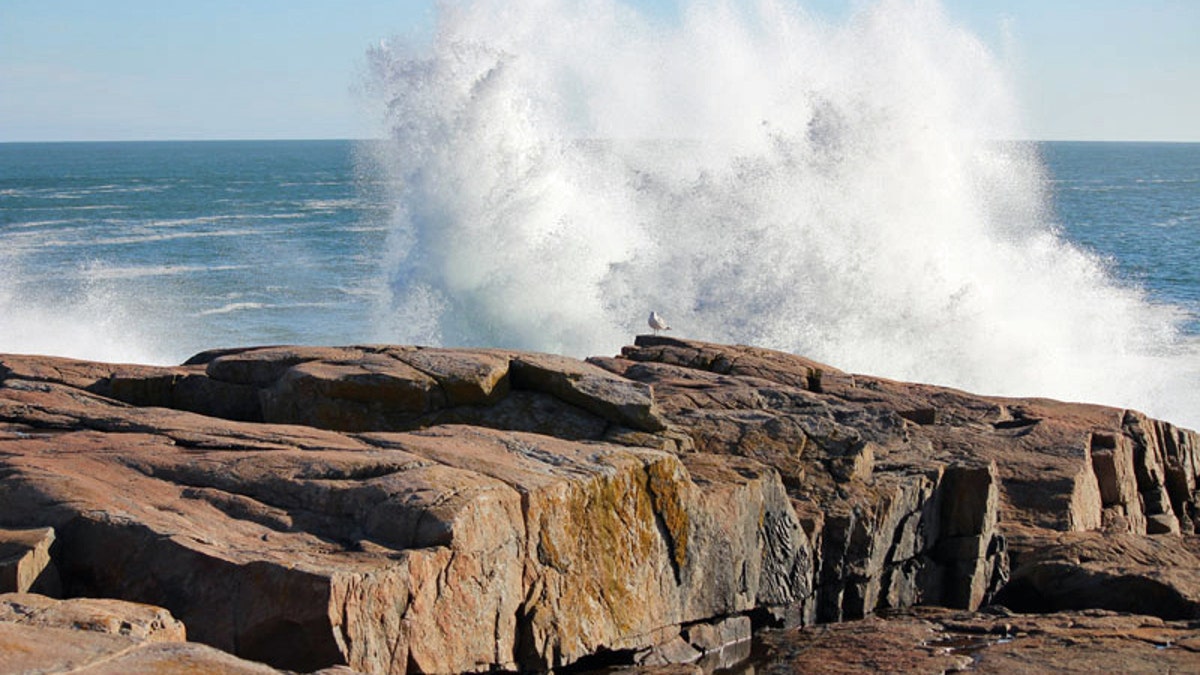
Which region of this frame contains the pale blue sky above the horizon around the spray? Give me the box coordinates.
[0,0,1200,142]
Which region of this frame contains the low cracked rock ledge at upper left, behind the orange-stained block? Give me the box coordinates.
[82,346,664,438]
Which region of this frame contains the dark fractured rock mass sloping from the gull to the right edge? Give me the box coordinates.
[592,336,1198,622]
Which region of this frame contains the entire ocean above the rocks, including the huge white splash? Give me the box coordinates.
[0,0,1200,428]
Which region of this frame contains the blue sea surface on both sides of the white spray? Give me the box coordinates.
[0,141,1200,363]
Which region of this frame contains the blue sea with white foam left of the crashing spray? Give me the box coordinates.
[0,141,391,363]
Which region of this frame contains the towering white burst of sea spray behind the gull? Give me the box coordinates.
[371,0,1200,426]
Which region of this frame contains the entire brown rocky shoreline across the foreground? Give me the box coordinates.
[0,336,1200,673]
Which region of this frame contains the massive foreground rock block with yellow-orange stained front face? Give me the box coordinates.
[0,348,812,673]
